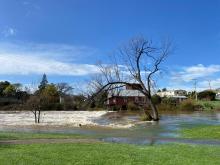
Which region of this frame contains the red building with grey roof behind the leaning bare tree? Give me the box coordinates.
[107,84,147,109]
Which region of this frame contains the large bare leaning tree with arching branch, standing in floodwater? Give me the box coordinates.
[94,37,171,121]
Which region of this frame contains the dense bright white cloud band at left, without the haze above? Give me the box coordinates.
[0,54,98,76]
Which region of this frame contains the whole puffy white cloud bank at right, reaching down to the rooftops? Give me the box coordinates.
[167,64,220,91]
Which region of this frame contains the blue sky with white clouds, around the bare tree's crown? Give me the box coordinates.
[0,0,220,90]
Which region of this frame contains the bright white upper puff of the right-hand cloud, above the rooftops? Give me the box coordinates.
[171,64,220,82]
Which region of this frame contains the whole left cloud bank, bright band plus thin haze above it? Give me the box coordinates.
[0,43,98,76]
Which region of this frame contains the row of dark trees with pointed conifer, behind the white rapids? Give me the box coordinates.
[0,74,104,110]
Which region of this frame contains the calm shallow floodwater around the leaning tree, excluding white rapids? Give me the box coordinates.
[0,112,220,145]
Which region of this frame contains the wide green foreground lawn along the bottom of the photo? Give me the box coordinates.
[0,143,220,165]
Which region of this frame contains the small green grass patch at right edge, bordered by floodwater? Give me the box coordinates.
[180,125,220,140]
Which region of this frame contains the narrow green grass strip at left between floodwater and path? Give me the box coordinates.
[0,132,89,140]
